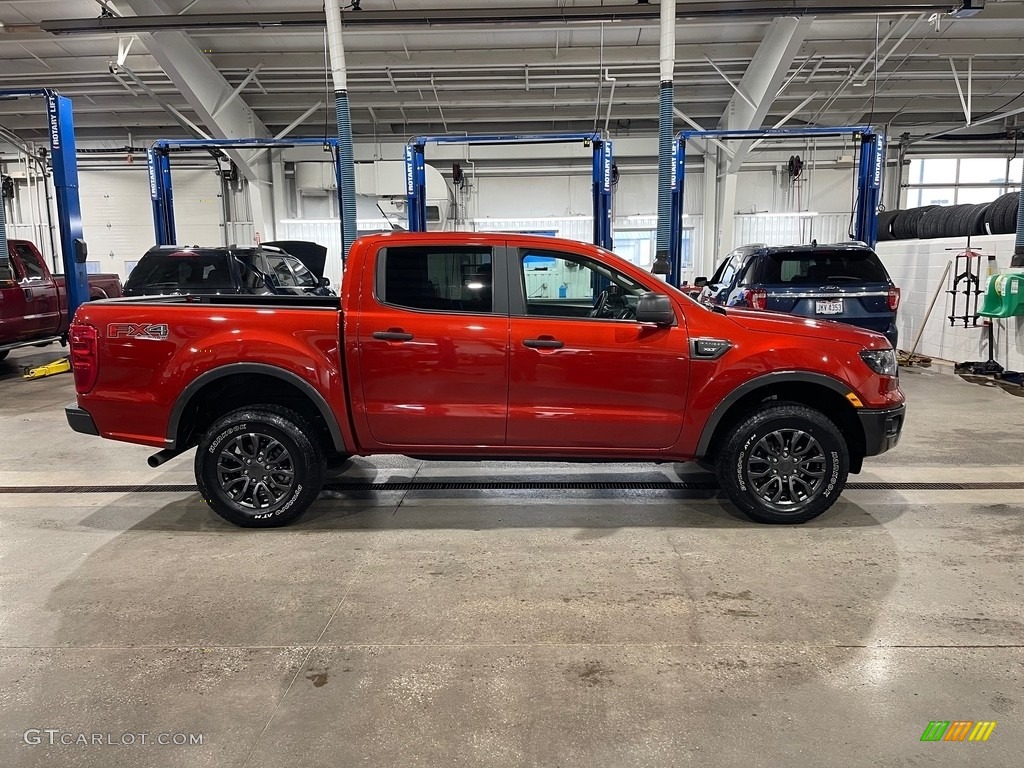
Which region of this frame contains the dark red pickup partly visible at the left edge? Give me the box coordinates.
[0,240,121,360]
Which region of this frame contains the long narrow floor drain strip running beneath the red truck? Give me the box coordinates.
[0,480,1024,494]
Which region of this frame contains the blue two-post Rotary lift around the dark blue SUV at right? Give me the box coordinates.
[669,125,886,287]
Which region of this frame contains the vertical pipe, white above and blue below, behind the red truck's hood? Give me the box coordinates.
[650,0,678,275]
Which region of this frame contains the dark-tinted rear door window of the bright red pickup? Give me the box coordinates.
[385,246,493,313]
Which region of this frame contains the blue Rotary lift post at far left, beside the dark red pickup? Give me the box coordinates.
[0,88,89,317]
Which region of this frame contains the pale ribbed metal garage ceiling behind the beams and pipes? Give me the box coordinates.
[0,0,1024,142]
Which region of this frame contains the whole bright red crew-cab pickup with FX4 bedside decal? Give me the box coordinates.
[67,232,904,527]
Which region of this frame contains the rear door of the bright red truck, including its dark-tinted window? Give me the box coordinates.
[353,244,509,446]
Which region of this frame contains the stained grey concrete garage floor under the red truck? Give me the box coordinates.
[0,350,1024,768]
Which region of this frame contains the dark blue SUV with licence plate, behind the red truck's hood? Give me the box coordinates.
[698,243,900,349]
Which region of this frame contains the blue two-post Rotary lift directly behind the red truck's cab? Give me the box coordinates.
[406,133,612,251]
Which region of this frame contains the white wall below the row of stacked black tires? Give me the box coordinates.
[878,234,1024,371]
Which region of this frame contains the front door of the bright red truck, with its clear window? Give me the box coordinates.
[508,248,689,451]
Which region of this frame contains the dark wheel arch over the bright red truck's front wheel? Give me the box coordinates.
[696,371,864,472]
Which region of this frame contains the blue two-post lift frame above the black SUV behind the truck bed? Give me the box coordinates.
[146,136,347,250]
